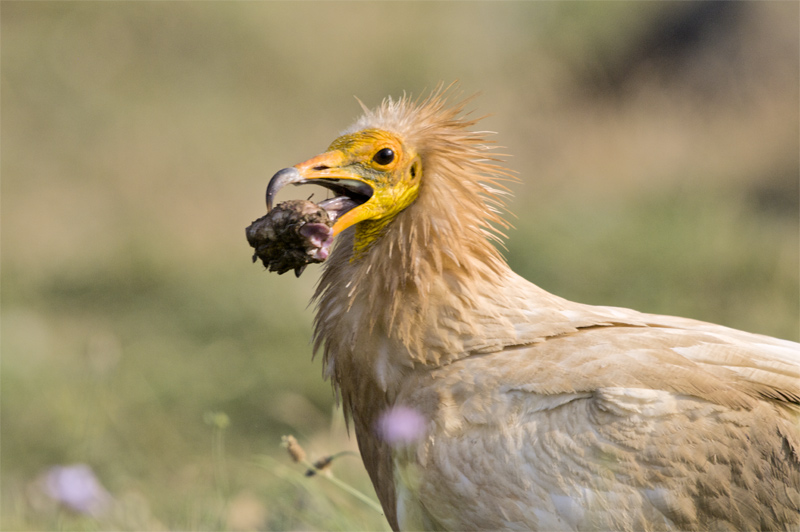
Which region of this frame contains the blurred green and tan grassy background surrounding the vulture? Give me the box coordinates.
[0,1,800,530]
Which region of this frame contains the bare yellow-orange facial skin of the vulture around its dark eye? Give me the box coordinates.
[295,129,422,256]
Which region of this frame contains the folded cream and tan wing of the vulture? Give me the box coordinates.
[394,324,800,530]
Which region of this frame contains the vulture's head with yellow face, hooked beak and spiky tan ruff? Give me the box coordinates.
[267,88,510,272]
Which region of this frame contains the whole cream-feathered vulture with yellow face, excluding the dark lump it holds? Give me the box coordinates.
[268,90,800,530]
